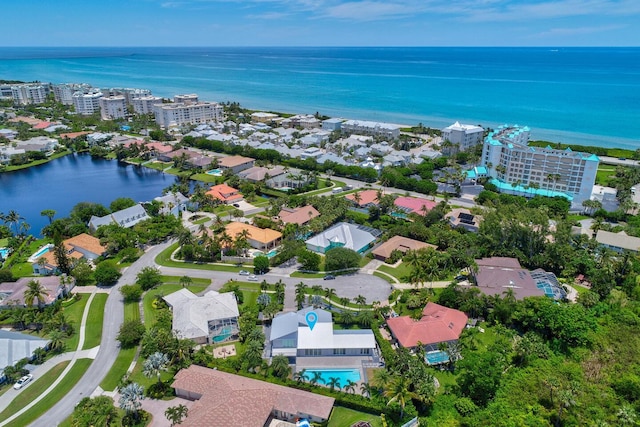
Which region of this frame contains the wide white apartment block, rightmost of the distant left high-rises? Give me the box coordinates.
[153,102,223,129]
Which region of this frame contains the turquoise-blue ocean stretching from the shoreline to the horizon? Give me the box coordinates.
[0,47,640,149]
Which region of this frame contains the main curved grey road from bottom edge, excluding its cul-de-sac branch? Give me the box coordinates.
[31,243,169,427]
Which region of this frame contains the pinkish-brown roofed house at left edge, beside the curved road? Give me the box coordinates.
[0,276,75,308]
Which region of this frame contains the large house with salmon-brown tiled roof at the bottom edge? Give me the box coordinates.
[171,365,335,427]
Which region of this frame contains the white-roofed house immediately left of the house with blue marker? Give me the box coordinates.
[163,289,240,342]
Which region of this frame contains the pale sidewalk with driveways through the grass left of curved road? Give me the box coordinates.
[0,287,100,427]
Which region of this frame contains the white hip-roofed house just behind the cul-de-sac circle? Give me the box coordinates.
[305,222,379,253]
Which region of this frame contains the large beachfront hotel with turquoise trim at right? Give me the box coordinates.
[481,125,600,207]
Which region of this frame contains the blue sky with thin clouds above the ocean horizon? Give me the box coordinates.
[5,0,640,46]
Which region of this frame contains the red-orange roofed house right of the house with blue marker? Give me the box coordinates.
[387,302,469,351]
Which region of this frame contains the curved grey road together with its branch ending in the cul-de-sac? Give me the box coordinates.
[31,242,391,427]
